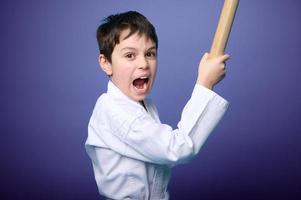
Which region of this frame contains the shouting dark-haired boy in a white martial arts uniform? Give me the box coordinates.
[86,11,229,200]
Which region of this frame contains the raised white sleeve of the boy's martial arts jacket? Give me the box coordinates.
[99,85,228,165]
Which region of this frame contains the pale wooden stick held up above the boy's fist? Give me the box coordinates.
[209,0,239,58]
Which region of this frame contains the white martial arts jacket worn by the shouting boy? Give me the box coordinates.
[86,81,228,200]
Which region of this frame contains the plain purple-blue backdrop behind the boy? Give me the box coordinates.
[0,0,301,200]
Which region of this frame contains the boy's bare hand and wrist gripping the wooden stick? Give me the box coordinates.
[197,53,230,90]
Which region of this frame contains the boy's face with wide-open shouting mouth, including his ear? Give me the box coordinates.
[99,30,157,101]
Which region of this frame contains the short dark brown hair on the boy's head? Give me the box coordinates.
[96,11,158,62]
